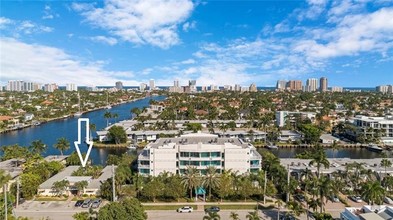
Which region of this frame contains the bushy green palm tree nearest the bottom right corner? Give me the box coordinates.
[362,181,385,205]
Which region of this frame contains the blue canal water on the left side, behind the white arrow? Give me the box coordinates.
[0,96,165,164]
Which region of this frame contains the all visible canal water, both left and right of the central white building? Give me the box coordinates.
[0,96,386,164]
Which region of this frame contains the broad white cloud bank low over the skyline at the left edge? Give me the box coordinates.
[0,38,139,85]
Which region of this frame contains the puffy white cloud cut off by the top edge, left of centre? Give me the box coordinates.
[72,0,194,49]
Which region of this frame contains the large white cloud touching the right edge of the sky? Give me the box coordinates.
[294,8,393,58]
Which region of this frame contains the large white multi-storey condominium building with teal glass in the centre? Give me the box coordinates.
[138,133,262,176]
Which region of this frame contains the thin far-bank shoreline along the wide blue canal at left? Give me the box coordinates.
[0,96,146,134]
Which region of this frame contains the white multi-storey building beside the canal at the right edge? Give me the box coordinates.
[354,115,393,137]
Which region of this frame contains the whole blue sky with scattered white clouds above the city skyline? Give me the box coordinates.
[0,0,393,87]
